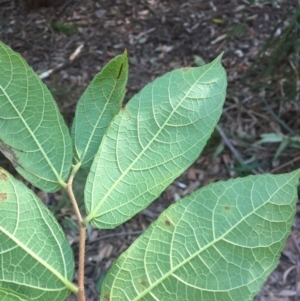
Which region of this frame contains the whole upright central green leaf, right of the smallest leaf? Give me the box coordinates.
[84,56,227,228]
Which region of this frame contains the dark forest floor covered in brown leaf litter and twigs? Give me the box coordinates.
[0,0,300,301]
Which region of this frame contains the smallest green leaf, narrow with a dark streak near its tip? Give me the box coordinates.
[72,51,128,168]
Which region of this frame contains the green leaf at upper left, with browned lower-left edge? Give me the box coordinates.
[0,42,72,192]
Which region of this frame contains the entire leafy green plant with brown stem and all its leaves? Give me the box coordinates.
[0,39,300,301]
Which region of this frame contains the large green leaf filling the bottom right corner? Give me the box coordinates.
[100,170,300,301]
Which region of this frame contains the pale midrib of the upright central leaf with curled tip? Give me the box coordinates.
[84,60,220,224]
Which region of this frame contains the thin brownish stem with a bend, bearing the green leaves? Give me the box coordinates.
[67,163,86,301]
